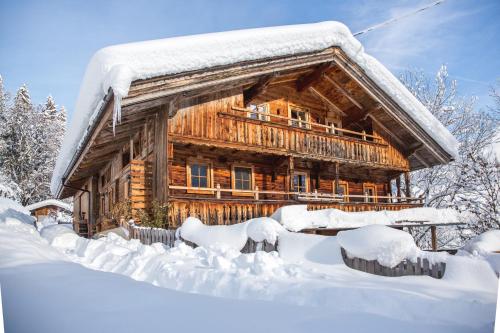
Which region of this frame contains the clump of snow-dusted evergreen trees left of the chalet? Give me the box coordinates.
[0,77,66,205]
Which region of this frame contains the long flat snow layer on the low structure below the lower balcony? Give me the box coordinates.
[271,205,460,231]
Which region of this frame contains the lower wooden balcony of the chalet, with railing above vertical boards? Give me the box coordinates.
[169,186,423,227]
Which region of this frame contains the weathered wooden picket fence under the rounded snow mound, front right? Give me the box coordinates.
[340,247,446,279]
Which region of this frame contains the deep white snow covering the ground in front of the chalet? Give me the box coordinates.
[0,198,497,333]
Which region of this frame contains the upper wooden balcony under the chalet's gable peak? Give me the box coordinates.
[169,106,409,171]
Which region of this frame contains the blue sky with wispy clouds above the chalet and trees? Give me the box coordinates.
[0,0,500,115]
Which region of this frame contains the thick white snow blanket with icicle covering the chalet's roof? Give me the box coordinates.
[51,22,458,194]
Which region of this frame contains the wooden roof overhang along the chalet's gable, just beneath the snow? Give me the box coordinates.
[57,47,453,198]
